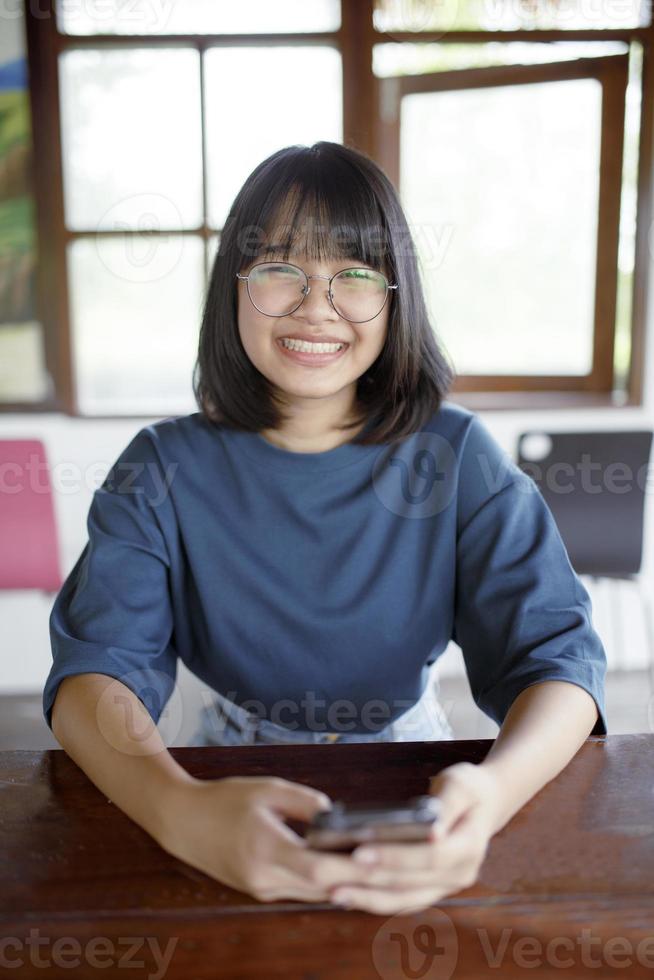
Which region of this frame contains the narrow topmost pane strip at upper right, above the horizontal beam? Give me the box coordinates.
[374,0,650,33]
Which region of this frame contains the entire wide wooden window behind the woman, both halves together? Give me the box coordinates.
[9,0,654,416]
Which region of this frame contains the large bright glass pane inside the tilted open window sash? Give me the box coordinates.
[401,79,601,374]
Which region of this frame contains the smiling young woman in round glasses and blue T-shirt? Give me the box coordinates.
[43,142,606,913]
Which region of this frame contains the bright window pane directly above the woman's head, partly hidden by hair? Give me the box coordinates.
[205,46,343,228]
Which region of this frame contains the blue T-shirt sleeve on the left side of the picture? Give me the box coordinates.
[43,429,177,728]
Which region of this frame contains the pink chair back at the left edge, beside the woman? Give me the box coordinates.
[0,439,62,592]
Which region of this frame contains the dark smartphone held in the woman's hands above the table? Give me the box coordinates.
[304,796,441,851]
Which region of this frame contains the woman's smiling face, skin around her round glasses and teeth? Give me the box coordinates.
[238,252,390,413]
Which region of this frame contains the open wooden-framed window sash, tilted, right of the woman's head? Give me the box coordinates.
[382,54,628,392]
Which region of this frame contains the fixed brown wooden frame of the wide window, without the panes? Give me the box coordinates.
[9,0,654,419]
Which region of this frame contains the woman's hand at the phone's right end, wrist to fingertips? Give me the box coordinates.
[330,762,499,914]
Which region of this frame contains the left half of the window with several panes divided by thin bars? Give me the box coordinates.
[23,0,343,416]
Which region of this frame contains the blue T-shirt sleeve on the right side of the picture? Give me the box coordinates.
[452,416,607,735]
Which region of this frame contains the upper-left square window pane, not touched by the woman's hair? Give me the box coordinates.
[60,48,202,231]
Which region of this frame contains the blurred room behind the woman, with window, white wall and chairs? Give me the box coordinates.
[0,0,654,748]
